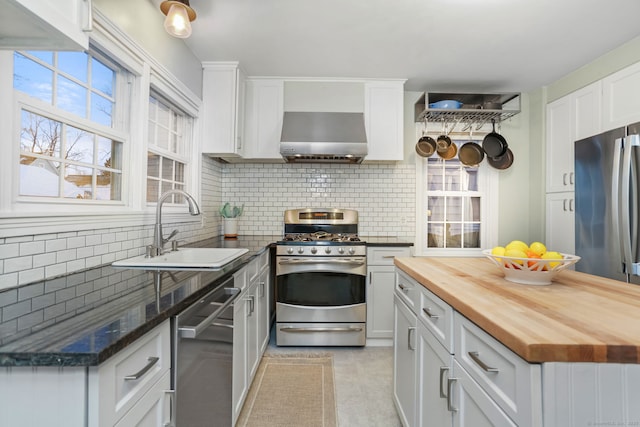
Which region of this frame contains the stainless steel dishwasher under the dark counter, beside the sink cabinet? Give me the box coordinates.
[172,277,240,427]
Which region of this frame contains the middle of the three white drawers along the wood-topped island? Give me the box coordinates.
[418,286,454,354]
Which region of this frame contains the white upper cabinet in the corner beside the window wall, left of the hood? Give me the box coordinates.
[202,62,245,157]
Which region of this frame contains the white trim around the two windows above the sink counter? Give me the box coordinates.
[0,10,202,238]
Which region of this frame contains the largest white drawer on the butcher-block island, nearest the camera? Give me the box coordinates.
[454,313,542,426]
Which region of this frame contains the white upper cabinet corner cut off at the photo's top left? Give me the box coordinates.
[0,0,92,50]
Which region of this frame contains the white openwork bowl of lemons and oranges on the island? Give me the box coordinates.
[482,240,580,285]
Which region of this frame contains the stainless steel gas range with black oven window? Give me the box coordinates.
[276,209,367,346]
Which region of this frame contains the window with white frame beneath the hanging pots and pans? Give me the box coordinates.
[416,142,495,255]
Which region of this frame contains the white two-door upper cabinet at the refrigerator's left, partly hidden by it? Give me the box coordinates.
[546,81,602,193]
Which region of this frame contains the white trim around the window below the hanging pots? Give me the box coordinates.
[414,156,499,257]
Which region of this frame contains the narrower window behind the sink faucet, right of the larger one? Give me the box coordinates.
[147,93,192,203]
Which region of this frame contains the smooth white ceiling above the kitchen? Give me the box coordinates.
[178,0,640,92]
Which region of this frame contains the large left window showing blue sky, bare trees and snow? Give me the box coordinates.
[13,51,126,202]
